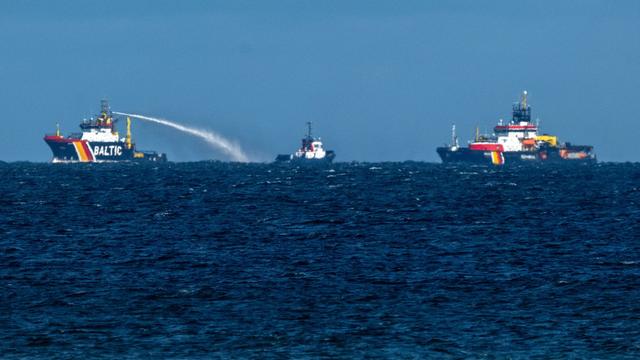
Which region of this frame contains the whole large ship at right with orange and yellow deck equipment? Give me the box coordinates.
[436,91,597,165]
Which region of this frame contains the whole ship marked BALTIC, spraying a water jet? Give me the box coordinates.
[44,100,167,163]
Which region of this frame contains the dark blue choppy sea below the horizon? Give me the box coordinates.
[0,162,640,359]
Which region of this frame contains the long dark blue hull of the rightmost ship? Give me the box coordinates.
[437,146,597,165]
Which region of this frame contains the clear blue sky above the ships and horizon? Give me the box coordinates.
[0,0,640,162]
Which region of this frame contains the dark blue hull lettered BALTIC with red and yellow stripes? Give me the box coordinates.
[44,136,167,163]
